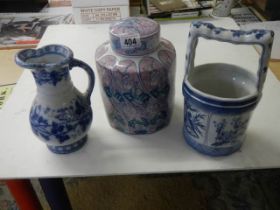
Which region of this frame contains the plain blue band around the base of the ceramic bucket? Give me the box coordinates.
[185,137,242,157]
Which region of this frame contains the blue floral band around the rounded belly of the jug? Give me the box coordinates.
[30,97,92,143]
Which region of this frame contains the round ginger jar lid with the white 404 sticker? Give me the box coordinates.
[110,17,160,56]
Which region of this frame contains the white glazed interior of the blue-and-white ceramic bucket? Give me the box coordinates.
[187,63,257,99]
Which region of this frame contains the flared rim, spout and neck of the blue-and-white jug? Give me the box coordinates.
[15,45,73,91]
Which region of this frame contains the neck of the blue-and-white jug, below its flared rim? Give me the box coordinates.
[32,64,73,95]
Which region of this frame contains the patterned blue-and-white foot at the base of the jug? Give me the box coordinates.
[48,136,87,154]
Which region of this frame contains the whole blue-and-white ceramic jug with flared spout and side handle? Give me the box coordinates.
[16,45,94,154]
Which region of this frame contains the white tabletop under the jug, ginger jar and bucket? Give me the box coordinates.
[0,18,280,179]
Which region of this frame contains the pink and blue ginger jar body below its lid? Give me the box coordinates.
[95,17,176,134]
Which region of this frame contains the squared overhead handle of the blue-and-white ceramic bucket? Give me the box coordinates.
[184,21,274,92]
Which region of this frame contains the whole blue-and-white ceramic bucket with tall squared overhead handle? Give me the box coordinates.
[183,22,273,156]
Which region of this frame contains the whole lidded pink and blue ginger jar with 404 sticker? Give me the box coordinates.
[95,18,176,134]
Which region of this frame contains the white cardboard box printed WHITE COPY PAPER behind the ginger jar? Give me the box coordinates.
[72,0,129,24]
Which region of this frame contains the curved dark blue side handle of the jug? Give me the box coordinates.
[70,58,95,104]
